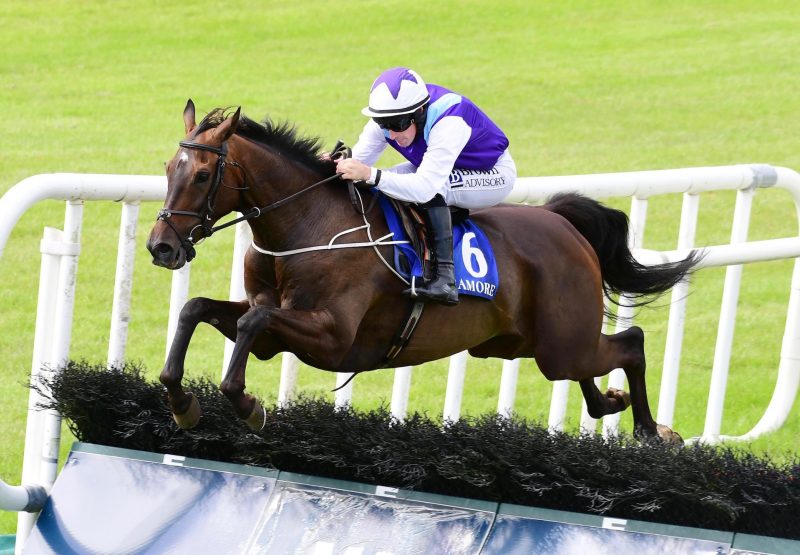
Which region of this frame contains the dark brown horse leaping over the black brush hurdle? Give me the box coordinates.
[147,99,702,442]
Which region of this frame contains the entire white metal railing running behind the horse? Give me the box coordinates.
[0,164,800,549]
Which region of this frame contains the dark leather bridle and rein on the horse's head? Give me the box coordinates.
[156,141,342,262]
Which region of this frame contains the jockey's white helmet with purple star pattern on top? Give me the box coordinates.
[361,67,430,118]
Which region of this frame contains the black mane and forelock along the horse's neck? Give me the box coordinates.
[194,108,334,175]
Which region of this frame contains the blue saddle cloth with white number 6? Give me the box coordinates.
[378,194,500,299]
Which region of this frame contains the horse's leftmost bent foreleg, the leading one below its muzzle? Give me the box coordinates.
[160,297,248,428]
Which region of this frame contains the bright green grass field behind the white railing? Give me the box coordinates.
[0,0,800,533]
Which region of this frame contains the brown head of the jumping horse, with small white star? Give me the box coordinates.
[147,100,241,270]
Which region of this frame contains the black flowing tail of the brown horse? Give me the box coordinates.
[544,193,703,306]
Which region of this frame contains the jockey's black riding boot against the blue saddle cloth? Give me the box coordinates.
[406,196,458,305]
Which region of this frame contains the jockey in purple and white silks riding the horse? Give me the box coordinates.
[337,67,517,305]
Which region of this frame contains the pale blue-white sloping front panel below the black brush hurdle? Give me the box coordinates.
[18,443,800,555]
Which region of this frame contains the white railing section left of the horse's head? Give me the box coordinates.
[0,174,166,554]
